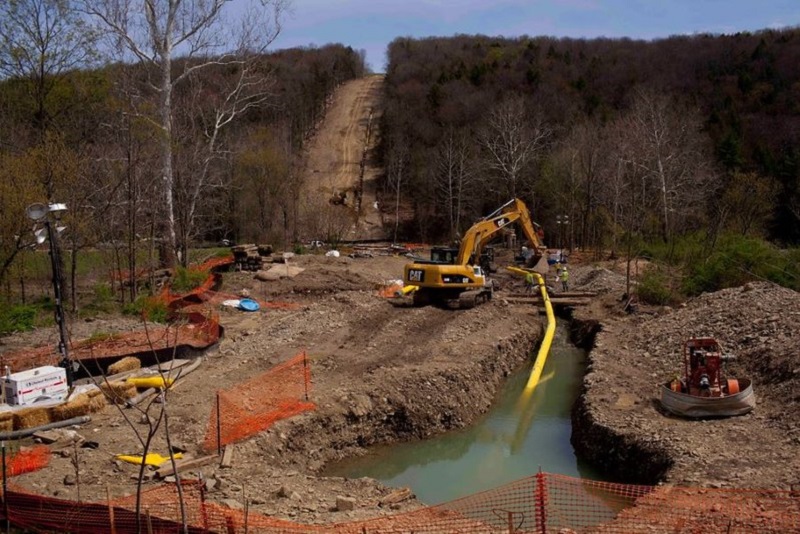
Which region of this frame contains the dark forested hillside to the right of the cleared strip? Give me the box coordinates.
[382,29,800,252]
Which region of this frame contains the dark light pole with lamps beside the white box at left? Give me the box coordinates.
[25,203,73,388]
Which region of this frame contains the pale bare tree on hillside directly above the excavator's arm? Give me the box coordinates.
[479,96,551,198]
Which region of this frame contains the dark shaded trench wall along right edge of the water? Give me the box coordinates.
[570,319,673,485]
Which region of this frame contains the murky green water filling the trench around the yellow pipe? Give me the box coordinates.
[325,323,598,504]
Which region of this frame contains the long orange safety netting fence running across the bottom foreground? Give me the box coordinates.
[4,473,800,534]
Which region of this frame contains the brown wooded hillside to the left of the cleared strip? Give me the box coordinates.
[0,40,365,298]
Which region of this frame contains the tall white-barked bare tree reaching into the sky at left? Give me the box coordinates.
[80,0,286,265]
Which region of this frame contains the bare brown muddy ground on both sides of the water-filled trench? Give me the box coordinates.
[4,249,800,523]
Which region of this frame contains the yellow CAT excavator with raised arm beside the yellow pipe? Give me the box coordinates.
[403,198,545,308]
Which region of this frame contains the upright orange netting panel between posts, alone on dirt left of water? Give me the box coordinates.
[204,352,315,451]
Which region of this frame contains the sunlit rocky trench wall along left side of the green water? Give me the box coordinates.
[259,328,543,473]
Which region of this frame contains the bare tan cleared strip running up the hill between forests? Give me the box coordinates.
[302,75,386,240]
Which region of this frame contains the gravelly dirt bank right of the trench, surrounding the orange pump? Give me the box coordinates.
[573,271,800,489]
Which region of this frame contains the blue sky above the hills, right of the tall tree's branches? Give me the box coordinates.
[273,0,800,72]
